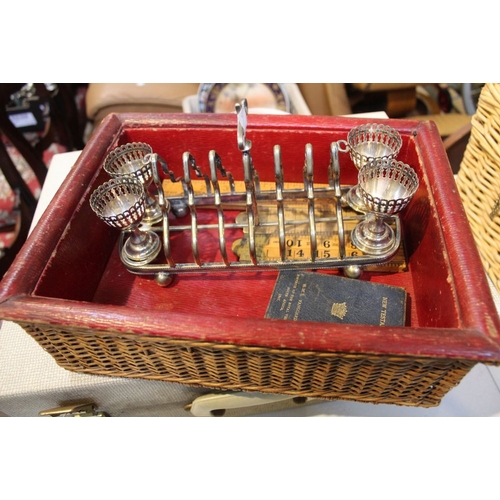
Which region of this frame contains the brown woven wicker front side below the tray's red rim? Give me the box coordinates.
[20,323,474,407]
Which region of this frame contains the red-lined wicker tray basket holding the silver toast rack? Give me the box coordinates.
[0,110,500,407]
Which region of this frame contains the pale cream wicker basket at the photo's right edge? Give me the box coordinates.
[457,83,500,290]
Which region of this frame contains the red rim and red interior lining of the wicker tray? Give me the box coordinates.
[0,114,500,404]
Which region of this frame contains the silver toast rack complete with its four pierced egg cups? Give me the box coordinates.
[90,100,418,286]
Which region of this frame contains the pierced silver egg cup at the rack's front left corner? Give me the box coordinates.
[90,177,161,267]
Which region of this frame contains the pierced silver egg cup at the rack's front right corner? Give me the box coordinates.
[351,159,419,255]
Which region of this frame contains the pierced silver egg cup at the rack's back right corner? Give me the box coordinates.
[346,123,403,212]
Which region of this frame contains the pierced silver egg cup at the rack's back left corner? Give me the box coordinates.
[104,142,163,224]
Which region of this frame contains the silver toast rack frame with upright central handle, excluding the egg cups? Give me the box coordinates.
[109,106,401,286]
